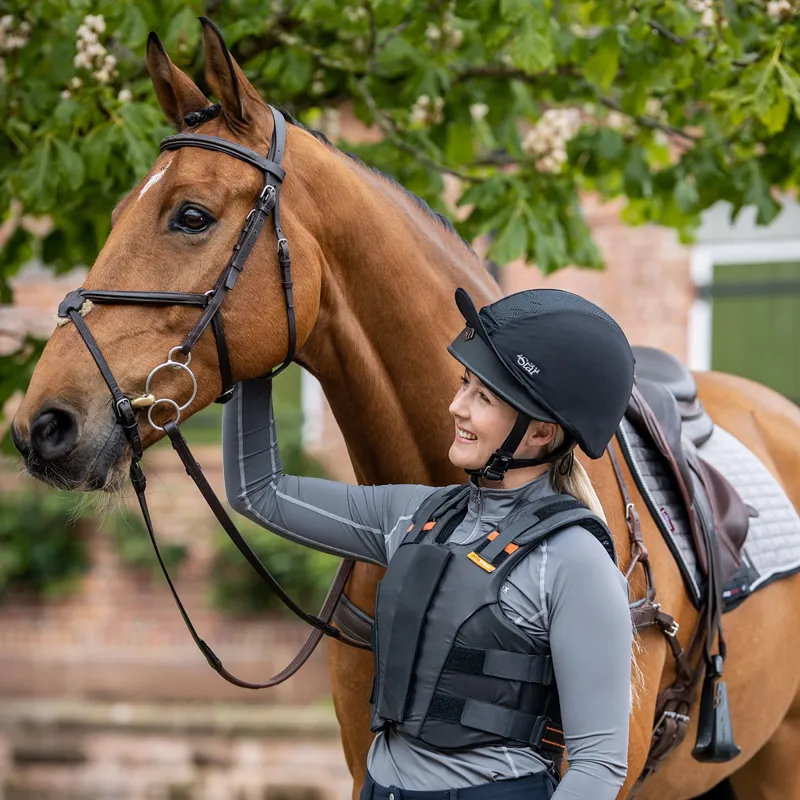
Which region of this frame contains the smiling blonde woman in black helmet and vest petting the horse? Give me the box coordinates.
[223,289,633,800]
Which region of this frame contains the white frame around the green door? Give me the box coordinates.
[687,239,800,371]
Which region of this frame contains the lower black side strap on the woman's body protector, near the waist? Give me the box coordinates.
[428,692,564,753]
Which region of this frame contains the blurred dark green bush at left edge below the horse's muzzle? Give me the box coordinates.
[0,491,89,597]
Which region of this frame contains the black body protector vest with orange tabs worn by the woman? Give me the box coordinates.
[370,486,616,762]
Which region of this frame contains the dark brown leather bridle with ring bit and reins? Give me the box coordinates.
[58,106,368,689]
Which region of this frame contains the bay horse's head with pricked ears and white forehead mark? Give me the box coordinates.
[12,20,321,490]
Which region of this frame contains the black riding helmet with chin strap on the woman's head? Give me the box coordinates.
[448,289,634,480]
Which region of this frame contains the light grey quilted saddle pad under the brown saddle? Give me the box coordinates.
[619,419,800,611]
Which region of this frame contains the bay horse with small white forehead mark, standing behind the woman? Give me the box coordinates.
[13,20,800,800]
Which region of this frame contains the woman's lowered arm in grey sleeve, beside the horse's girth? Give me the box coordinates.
[545,528,633,800]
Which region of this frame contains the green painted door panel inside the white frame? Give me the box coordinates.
[708,262,800,404]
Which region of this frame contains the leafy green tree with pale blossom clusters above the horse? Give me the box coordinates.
[0,0,800,401]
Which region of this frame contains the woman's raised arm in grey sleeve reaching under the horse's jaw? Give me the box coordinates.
[222,378,433,566]
